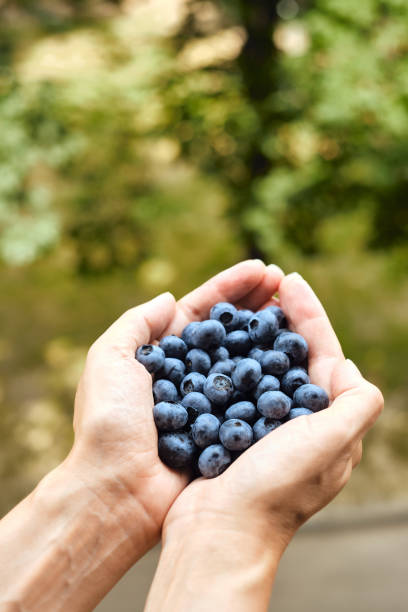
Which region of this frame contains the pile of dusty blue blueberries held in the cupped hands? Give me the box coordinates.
[136,302,329,478]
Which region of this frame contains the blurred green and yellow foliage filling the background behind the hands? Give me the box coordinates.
[0,0,408,510]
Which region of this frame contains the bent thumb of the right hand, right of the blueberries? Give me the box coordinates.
[314,359,384,444]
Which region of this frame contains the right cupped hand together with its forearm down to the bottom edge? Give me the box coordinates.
[145,274,383,612]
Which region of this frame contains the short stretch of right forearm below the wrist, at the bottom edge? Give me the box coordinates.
[145,526,282,612]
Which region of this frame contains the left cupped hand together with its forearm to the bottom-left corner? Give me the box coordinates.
[0,260,283,612]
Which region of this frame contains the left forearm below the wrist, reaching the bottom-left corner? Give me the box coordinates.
[0,465,154,612]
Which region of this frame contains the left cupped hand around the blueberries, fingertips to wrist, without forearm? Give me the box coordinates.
[66,260,283,545]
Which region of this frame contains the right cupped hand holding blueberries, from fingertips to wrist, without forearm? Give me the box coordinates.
[164,274,383,553]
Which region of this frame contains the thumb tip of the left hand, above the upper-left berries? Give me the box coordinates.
[95,292,176,355]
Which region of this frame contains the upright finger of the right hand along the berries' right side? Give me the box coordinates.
[279,273,344,391]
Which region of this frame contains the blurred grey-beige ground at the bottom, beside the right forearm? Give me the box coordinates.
[96,504,408,612]
